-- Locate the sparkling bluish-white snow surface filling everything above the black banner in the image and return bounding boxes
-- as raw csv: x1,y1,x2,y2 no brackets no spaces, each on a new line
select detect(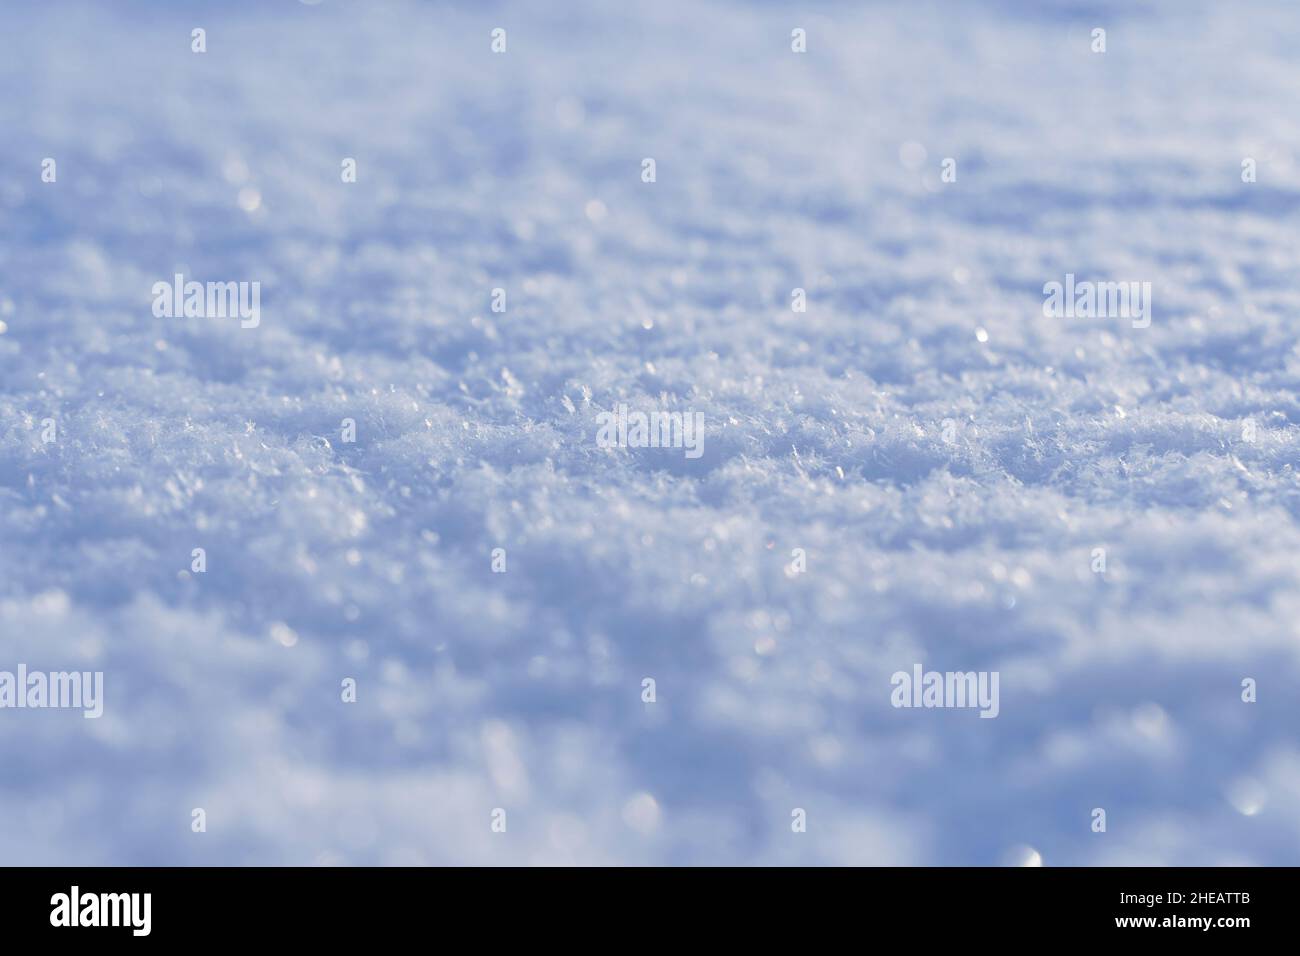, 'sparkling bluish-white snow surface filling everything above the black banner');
0,0,1300,865
